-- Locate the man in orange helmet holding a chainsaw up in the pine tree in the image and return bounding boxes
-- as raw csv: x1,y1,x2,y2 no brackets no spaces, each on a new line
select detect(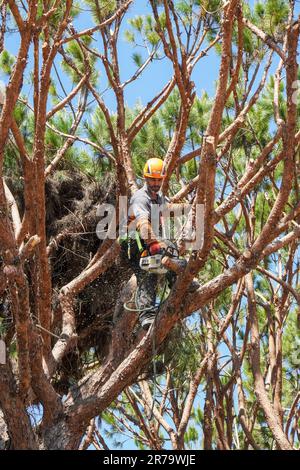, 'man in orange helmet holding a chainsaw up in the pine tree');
121,158,199,330
